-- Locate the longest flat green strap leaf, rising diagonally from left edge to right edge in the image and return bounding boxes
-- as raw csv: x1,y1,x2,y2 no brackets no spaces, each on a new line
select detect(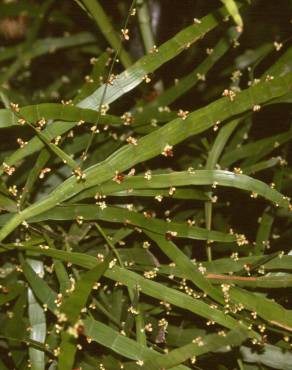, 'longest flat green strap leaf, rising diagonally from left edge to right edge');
0,73,292,241
